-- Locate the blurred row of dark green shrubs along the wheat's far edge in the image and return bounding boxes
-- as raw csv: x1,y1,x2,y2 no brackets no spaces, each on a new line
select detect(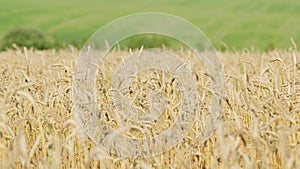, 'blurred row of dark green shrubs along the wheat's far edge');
0,27,296,52
